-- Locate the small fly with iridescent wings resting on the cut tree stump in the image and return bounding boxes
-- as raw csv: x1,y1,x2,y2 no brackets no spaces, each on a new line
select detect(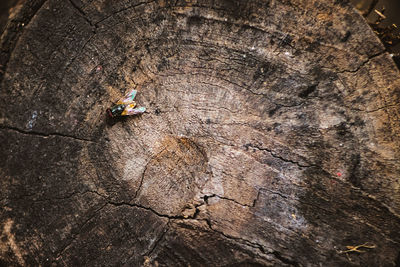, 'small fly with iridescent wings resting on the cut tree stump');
106,90,146,118
